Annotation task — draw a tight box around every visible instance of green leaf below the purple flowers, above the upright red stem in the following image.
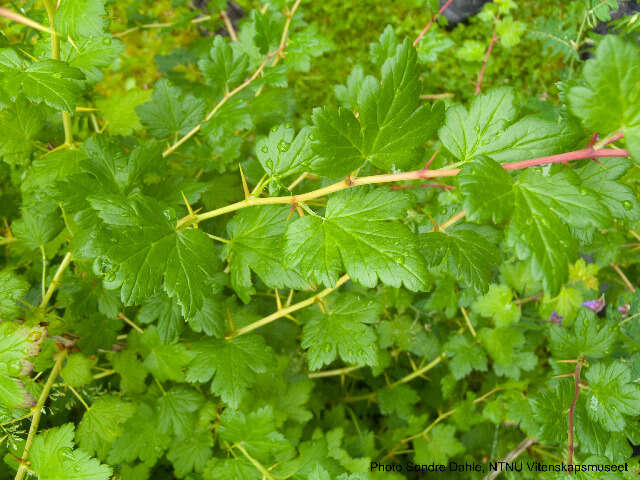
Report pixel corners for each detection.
[549,308,617,359]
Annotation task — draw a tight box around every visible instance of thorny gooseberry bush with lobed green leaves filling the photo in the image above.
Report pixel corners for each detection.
[0,0,640,480]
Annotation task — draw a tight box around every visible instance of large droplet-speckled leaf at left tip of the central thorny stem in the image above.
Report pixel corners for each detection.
[89,196,220,317]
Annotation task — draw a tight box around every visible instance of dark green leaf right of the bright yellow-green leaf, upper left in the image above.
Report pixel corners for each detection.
[135,79,205,138]
